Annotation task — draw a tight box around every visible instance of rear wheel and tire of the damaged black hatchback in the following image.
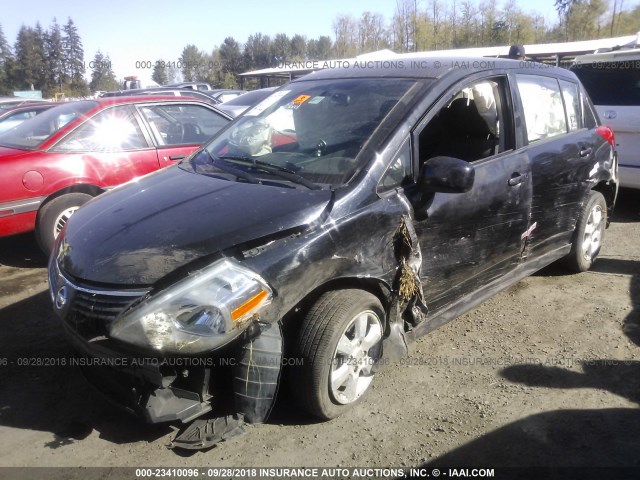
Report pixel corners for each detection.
[565,191,607,273]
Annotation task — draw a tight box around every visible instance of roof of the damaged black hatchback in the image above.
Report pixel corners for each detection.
[294,55,575,83]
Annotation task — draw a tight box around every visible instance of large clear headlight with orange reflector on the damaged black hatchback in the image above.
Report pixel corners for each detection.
[109,259,273,354]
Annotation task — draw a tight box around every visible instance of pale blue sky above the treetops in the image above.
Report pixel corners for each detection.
[0,0,564,78]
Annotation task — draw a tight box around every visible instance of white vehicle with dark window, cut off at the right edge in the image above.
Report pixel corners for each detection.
[571,49,640,188]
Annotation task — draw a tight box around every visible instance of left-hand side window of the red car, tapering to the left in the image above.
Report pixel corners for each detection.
[53,105,148,152]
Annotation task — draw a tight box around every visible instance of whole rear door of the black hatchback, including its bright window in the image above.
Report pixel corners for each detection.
[515,73,609,258]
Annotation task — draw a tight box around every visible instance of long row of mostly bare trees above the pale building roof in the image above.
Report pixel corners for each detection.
[161,0,640,88]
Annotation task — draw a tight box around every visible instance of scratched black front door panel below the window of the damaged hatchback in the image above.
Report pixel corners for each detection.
[416,152,531,311]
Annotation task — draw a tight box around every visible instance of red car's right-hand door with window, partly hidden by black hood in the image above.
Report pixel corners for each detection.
[138,102,229,167]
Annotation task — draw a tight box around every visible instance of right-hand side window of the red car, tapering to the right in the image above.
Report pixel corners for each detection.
[140,104,228,145]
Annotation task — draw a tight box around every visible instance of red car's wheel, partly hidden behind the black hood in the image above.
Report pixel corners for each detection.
[36,193,93,255]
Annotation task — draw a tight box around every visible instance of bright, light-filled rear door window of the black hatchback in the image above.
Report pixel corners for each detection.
[516,75,567,142]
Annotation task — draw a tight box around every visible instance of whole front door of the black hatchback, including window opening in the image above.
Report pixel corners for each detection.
[414,75,531,312]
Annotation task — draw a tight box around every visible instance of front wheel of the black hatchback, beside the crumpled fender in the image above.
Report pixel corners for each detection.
[292,290,384,420]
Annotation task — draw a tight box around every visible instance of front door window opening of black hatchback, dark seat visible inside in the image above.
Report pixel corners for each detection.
[418,78,511,166]
